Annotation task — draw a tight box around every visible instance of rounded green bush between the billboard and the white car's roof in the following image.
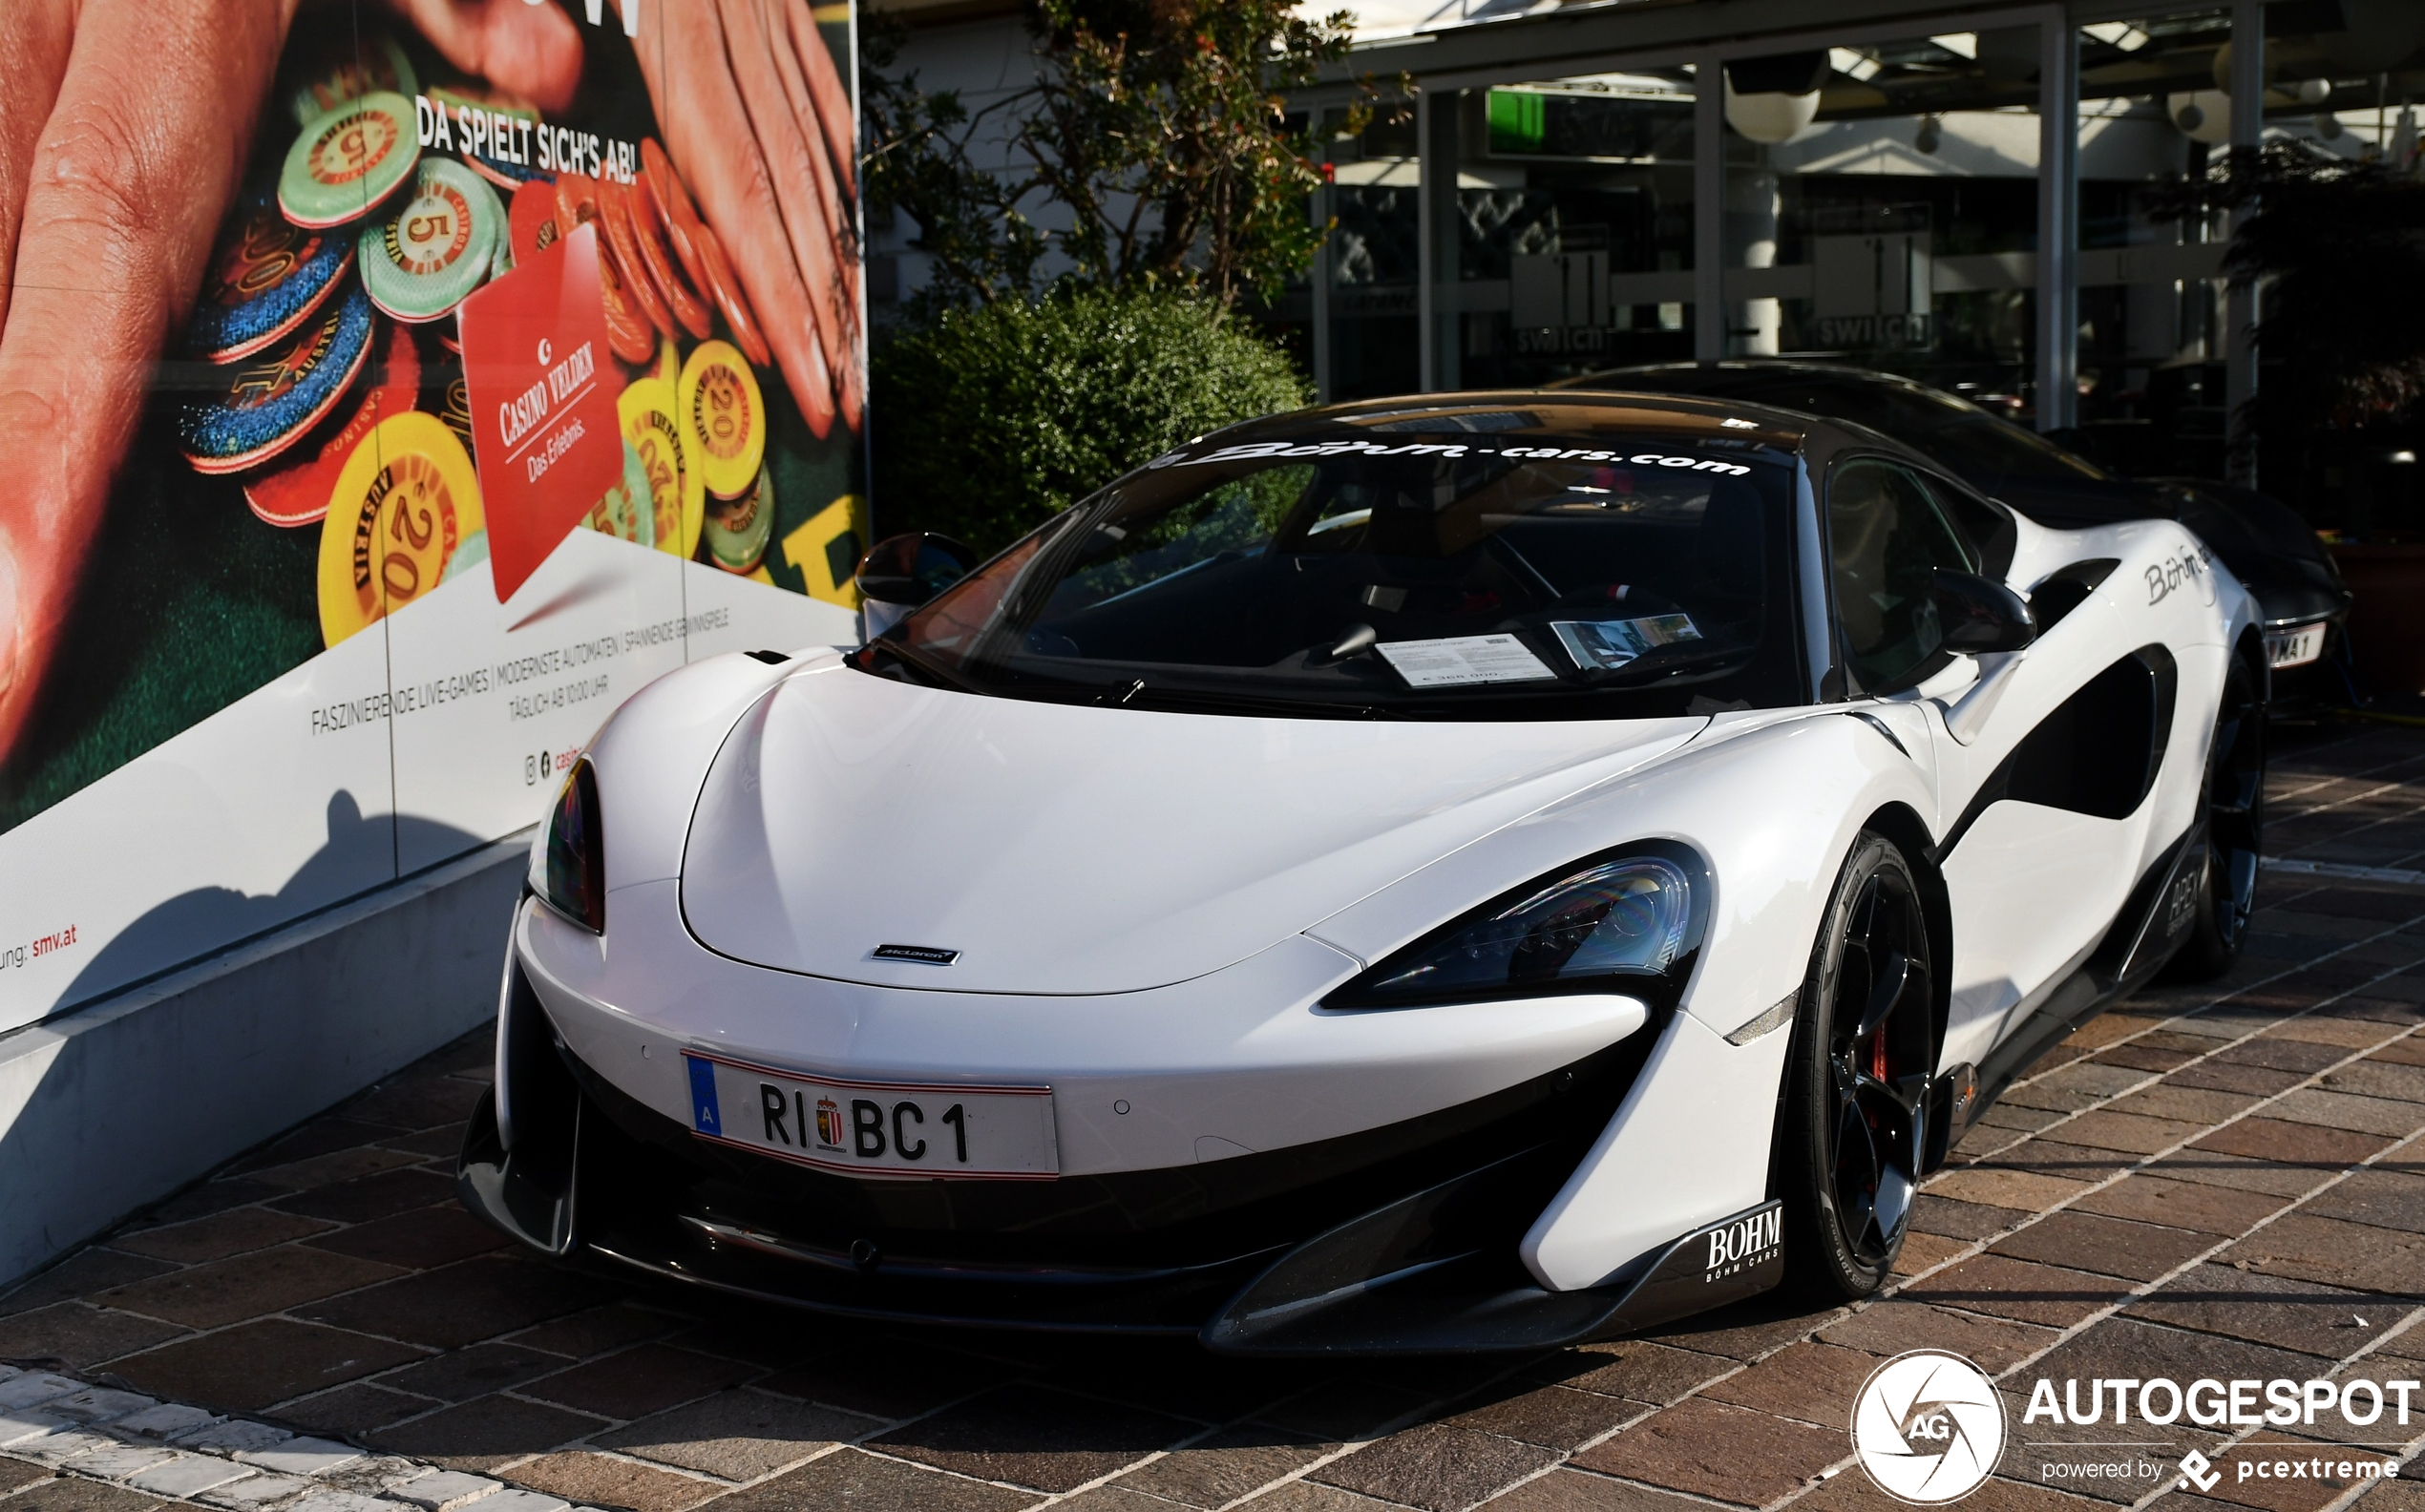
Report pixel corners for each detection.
[868,293,1312,555]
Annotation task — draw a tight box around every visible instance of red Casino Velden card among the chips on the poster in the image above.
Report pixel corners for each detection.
[458,225,623,603]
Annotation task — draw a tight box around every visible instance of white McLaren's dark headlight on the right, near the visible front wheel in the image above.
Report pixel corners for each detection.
[1324,841,1710,1008]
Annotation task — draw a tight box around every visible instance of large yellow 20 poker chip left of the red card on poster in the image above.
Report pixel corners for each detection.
[320,410,488,644]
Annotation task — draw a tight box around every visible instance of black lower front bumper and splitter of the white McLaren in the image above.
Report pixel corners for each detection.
[458,892,1780,1354]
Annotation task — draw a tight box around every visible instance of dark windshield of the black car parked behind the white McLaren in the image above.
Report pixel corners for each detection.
[1600,368,2107,492]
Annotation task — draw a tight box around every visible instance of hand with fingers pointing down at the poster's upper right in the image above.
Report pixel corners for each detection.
[633,0,866,433]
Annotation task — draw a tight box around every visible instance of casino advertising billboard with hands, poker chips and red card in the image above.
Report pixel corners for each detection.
[0,0,866,1030]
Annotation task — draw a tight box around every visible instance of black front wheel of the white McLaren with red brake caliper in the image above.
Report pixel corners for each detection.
[1778,833,1935,1299]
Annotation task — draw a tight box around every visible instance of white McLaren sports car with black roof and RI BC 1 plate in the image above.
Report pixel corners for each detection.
[458,392,2267,1354]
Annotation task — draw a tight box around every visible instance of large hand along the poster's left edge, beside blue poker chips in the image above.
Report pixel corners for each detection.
[0,0,582,761]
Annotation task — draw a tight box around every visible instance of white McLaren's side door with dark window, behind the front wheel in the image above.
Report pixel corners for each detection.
[1828,455,2129,1066]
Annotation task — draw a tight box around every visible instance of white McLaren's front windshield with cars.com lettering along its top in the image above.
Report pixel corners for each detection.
[856,422,1802,720]
